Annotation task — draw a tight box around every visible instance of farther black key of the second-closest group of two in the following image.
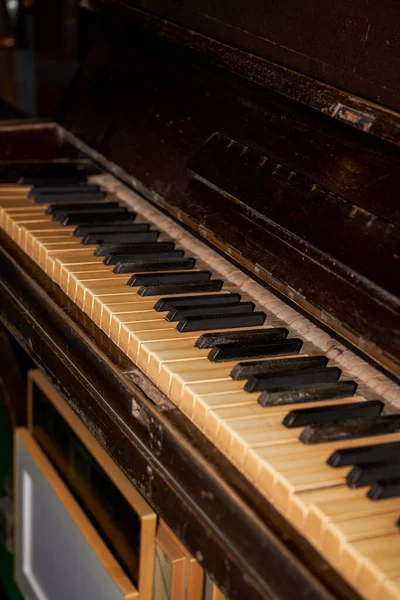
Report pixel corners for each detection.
[195,327,289,350]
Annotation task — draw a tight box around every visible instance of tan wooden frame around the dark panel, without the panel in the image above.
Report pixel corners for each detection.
[28,369,157,600]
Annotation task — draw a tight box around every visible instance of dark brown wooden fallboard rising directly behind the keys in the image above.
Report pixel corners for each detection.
[57,18,400,376]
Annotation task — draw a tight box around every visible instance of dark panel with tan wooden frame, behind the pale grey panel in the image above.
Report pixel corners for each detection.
[28,370,156,600]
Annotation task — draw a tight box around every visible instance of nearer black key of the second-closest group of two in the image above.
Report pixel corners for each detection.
[208,338,303,362]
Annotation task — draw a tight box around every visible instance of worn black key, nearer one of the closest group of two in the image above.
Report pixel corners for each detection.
[299,415,400,444]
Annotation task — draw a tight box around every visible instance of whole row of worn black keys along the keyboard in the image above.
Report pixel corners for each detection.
[32,177,400,506]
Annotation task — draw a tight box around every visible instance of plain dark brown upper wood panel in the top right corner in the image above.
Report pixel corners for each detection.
[117,0,400,110]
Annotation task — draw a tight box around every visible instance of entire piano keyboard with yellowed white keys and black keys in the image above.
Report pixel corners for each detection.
[0,171,400,600]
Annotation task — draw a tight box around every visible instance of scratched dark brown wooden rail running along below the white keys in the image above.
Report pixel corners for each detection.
[0,230,357,600]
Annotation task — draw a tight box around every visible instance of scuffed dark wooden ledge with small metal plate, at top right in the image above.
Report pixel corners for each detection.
[90,0,400,146]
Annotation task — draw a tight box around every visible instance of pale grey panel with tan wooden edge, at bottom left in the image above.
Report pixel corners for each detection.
[15,428,139,600]
